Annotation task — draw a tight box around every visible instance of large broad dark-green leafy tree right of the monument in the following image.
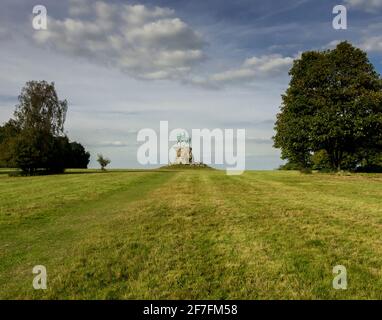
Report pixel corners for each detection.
[274,42,382,170]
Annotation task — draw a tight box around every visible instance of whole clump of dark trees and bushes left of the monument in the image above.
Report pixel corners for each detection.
[0,81,90,175]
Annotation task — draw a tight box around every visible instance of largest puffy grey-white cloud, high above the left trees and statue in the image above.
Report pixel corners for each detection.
[34,0,205,79]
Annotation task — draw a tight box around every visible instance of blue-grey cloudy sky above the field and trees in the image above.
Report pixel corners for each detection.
[0,0,382,170]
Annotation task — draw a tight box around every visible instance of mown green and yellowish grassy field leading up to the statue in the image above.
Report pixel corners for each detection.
[0,170,382,299]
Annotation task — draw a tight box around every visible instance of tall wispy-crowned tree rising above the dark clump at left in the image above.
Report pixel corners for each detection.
[13,81,67,174]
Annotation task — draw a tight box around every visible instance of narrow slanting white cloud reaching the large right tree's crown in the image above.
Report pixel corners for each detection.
[193,54,296,87]
